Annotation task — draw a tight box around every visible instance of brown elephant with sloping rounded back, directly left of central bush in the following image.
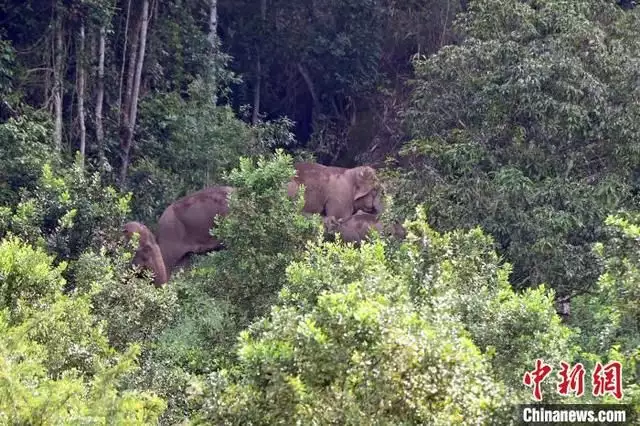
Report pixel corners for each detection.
[156,186,233,276]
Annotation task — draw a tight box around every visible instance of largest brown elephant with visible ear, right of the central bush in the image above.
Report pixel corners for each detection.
[287,163,382,219]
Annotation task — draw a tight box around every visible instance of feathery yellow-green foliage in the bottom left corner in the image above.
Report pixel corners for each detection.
[0,314,165,425]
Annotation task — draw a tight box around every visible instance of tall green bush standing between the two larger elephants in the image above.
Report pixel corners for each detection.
[214,151,323,317]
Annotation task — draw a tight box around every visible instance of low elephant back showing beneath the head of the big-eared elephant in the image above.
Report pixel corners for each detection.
[323,211,406,243]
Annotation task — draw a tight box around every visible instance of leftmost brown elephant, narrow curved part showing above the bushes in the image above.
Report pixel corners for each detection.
[122,222,168,287]
